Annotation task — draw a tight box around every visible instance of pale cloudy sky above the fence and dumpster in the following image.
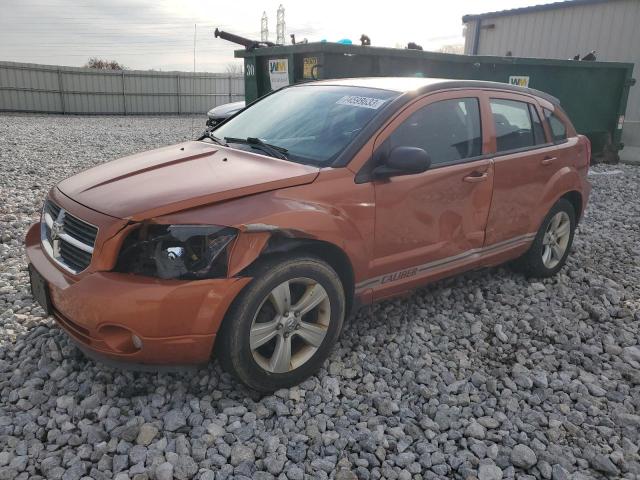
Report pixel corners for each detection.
[0,0,551,72]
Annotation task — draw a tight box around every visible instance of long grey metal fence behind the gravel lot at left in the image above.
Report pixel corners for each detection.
[0,62,244,115]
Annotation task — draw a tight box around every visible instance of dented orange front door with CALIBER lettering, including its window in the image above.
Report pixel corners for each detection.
[370,91,493,299]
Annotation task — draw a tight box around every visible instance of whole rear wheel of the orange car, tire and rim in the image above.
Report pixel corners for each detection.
[514,198,576,277]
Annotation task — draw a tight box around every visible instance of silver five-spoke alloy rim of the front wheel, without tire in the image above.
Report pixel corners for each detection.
[249,278,331,373]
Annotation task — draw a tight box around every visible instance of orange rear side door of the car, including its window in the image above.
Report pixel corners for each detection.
[482,92,568,246]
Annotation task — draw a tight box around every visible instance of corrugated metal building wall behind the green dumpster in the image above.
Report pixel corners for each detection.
[465,0,640,146]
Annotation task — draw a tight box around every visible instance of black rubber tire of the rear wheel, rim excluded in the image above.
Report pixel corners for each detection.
[513,198,576,278]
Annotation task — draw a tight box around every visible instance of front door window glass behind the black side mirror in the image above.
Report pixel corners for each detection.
[387,98,482,165]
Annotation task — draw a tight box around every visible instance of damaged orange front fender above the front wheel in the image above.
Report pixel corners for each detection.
[157,169,375,281]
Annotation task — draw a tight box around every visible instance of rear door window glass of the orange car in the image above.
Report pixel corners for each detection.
[490,98,536,152]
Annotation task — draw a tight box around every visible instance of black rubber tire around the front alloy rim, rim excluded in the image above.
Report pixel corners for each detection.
[216,255,345,392]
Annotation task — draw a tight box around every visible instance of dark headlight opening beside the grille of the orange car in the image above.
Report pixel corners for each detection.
[116,225,237,280]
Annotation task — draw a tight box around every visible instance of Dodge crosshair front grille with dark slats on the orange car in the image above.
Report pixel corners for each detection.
[40,200,98,273]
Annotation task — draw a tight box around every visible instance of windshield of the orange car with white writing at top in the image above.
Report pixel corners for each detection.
[214,85,398,166]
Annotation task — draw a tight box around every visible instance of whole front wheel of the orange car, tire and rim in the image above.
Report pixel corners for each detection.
[216,256,345,391]
